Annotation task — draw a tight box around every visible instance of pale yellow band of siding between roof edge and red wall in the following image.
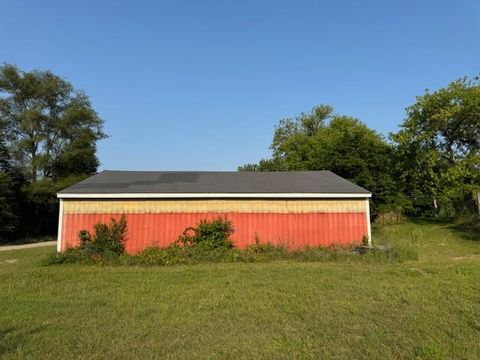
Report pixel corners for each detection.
[63,199,366,214]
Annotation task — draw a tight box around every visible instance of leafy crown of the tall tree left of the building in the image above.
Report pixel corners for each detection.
[0,64,105,182]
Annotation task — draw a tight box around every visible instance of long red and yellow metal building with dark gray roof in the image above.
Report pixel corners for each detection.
[57,171,371,253]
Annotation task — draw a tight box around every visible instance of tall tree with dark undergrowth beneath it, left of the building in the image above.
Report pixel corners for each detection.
[0,64,105,241]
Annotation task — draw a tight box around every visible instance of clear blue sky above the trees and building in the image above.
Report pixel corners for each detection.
[0,0,480,170]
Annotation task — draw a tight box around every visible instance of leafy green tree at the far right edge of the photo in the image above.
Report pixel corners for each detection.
[392,78,480,217]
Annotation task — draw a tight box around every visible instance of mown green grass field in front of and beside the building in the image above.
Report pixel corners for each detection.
[0,221,480,359]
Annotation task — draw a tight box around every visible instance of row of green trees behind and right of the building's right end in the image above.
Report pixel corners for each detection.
[238,77,480,218]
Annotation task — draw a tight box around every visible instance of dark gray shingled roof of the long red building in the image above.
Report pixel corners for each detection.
[59,170,370,195]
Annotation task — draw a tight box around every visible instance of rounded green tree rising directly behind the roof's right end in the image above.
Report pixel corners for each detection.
[239,105,405,215]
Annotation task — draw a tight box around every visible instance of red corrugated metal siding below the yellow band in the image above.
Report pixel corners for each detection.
[62,212,367,253]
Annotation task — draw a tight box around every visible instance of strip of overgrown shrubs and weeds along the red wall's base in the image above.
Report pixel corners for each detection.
[46,217,418,266]
